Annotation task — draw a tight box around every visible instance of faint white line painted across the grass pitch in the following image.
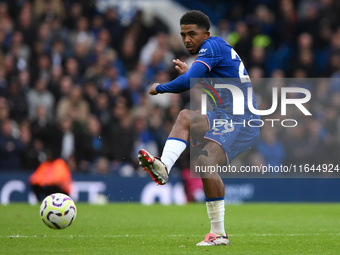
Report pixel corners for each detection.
[0,233,340,238]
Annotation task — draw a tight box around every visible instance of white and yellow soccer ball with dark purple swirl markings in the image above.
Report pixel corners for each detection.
[40,193,77,229]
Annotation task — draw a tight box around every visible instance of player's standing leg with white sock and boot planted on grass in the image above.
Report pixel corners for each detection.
[197,142,229,246]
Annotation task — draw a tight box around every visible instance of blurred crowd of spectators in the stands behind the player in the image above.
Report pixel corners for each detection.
[0,0,340,175]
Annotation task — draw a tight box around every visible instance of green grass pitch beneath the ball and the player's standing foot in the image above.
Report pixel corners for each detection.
[0,203,340,255]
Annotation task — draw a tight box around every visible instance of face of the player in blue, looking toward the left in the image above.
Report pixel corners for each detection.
[181,25,210,55]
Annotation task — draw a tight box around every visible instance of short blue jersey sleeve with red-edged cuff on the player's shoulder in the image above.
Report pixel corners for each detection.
[194,40,222,72]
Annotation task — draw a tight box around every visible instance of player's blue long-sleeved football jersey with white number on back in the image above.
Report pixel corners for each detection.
[156,36,258,119]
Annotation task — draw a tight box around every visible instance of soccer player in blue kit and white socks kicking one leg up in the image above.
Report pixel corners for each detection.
[138,10,260,246]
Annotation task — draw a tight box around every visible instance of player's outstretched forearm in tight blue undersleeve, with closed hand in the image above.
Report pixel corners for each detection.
[149,62,209,95]
